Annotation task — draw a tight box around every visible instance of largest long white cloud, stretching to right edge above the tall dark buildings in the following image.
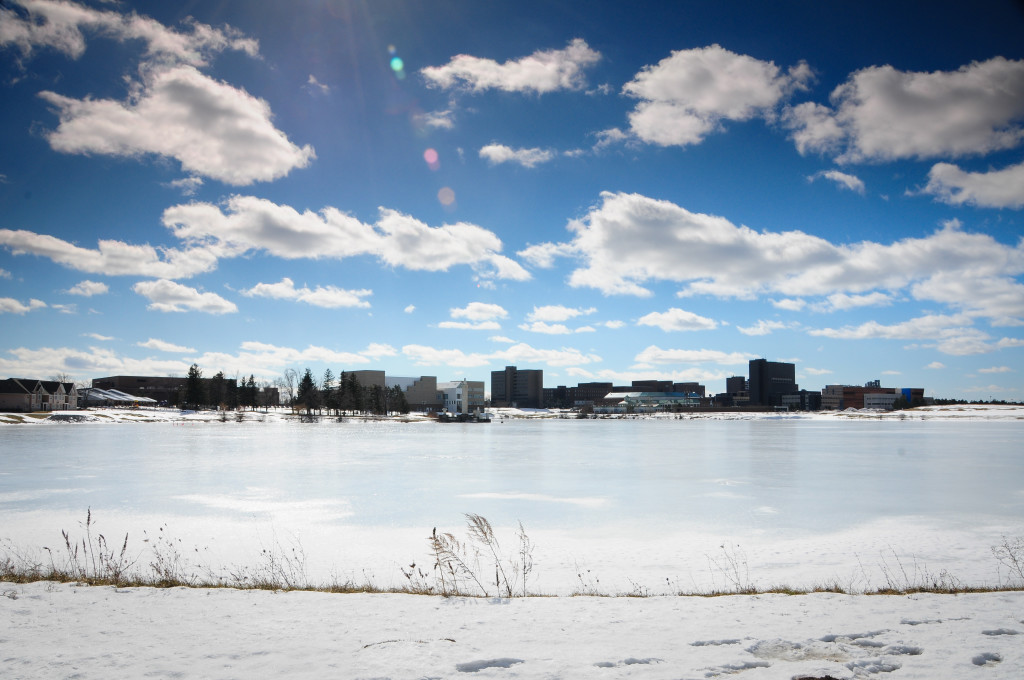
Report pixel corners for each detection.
[520,193,1024,325]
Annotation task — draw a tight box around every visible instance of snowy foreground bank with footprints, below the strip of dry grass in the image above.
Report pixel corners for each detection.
[0,583,1024,680]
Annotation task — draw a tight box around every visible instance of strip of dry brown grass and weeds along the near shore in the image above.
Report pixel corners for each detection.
[0,509,1024,598]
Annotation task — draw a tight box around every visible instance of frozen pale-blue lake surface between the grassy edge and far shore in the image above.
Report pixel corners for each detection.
[0,411,1024,591]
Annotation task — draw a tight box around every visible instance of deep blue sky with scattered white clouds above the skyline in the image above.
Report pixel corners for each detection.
[0,0,1024,399]
